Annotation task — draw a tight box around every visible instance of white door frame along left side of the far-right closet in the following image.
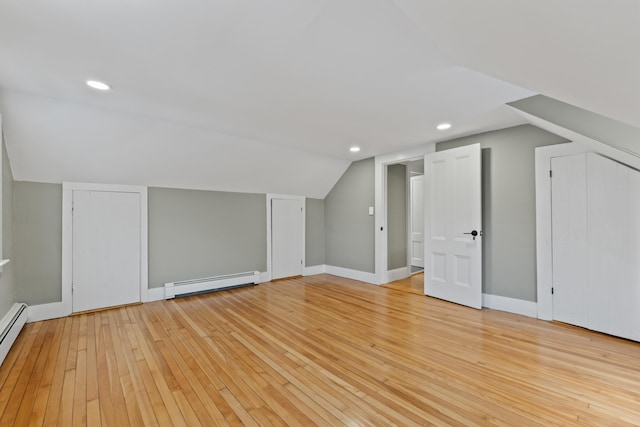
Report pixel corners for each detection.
[536,142,592,320]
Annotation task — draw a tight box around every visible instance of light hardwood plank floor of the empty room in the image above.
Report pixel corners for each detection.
[0,275,640,427]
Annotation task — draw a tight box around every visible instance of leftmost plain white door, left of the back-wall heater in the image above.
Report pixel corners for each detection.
[72,190,141,312]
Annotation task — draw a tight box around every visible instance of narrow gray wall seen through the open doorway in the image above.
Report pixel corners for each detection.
[387,162,408,270]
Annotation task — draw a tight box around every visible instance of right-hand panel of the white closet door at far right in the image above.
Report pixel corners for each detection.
[586,153,640,340]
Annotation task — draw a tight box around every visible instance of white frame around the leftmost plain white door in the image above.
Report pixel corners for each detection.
[61,182,149,317]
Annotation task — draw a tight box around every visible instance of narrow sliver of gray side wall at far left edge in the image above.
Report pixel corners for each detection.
[0,141,17,319]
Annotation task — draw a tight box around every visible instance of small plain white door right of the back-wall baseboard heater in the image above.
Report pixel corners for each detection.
[271,199,303,279]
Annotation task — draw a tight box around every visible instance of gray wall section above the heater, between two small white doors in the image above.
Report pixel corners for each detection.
[149,188,267,288]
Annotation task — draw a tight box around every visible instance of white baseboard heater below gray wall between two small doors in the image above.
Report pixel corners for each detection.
[164,271,260,299]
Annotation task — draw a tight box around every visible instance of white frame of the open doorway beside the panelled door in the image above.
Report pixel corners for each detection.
[374,143,436,285]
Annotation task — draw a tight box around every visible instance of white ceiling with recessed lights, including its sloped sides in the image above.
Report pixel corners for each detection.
[0,0,640,197]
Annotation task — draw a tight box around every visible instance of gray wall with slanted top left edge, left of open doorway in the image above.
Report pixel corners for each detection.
[324,158,375,273]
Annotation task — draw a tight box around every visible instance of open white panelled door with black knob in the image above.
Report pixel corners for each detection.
[424,144,482,308]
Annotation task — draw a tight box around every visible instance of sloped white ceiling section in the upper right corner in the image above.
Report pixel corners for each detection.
[394,0,640,127]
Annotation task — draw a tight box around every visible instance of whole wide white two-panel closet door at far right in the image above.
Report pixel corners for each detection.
[551,153,640,341]
